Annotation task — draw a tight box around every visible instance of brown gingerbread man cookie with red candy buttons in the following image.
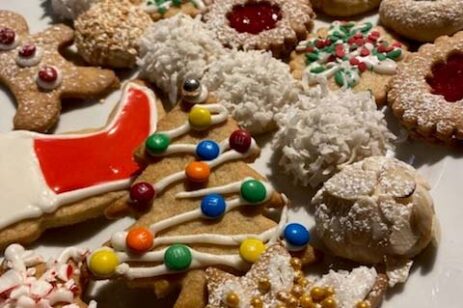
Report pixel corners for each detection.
[0,11,118,132]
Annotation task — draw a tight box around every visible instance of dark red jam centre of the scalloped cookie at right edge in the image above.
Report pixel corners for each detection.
[426,53,463,103]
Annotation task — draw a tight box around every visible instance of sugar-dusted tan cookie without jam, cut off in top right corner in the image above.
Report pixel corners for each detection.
[379,0,463,42]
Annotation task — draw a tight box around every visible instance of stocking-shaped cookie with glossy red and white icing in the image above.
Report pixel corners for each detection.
[0,83,162,248]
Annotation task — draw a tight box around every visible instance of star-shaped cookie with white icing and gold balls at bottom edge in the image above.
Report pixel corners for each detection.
[206,243,387,308]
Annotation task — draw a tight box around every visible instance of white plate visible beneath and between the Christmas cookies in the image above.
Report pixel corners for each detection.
[0,0,463,308]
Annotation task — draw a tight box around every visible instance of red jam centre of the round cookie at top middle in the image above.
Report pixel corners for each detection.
[227,1,281,34]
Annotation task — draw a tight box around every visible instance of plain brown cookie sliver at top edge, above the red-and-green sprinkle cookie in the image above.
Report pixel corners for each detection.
[310,0,381,17]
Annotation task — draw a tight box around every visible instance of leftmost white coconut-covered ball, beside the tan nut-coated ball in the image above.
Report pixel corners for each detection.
[138,14,225,103]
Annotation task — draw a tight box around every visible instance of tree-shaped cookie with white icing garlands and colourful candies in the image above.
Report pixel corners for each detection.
[88,80,315,307]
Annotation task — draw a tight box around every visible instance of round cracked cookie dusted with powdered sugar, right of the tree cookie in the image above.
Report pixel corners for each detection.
[312,156,437,284]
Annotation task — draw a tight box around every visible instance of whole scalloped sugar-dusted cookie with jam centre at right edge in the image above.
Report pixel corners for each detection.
[388,32,463,143]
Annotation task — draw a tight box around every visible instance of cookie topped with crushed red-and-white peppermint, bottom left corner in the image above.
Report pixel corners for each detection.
[0,244,96,308]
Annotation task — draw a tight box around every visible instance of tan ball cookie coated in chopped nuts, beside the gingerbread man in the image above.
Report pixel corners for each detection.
[75,0,152,68]
